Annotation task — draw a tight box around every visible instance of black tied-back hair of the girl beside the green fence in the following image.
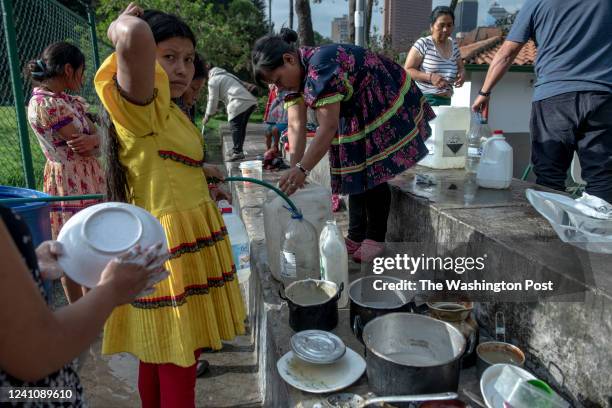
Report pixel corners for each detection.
[26,42,85,84]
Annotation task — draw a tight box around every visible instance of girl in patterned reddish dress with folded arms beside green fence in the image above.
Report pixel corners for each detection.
[26,42,106,303]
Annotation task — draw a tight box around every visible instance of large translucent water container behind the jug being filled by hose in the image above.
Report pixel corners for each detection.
[264,183,333,280]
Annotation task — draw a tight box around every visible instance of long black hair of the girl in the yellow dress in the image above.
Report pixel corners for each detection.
[103,10,196,202]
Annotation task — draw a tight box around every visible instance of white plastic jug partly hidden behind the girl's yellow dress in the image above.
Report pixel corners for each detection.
[218,200,251,283]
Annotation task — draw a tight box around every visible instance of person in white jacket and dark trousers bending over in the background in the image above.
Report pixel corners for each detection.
[202,67,257,161]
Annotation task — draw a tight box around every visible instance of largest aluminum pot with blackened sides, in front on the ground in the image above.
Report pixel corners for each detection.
[363,313,466,404]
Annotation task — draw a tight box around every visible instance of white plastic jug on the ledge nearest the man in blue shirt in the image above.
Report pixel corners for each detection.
[476,130,513,189]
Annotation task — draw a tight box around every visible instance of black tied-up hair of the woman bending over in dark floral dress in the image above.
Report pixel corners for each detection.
[251,28,298,87]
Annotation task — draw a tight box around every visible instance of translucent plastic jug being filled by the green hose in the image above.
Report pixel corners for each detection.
[278,216,321,286]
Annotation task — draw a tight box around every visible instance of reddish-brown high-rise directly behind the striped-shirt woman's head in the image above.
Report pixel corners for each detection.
[383,0,431,52]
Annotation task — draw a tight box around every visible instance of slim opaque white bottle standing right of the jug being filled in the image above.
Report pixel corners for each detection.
[319,221,349,308]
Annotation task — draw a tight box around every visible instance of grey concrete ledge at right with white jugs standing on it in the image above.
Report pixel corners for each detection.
[387,168,612,407]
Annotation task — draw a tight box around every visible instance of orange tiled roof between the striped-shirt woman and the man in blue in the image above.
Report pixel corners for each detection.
[459,36,537,66]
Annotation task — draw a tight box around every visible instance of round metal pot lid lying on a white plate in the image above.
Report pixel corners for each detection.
[291,330,346,364]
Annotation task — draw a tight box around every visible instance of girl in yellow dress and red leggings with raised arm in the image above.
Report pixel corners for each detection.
[95,3,245,408]
